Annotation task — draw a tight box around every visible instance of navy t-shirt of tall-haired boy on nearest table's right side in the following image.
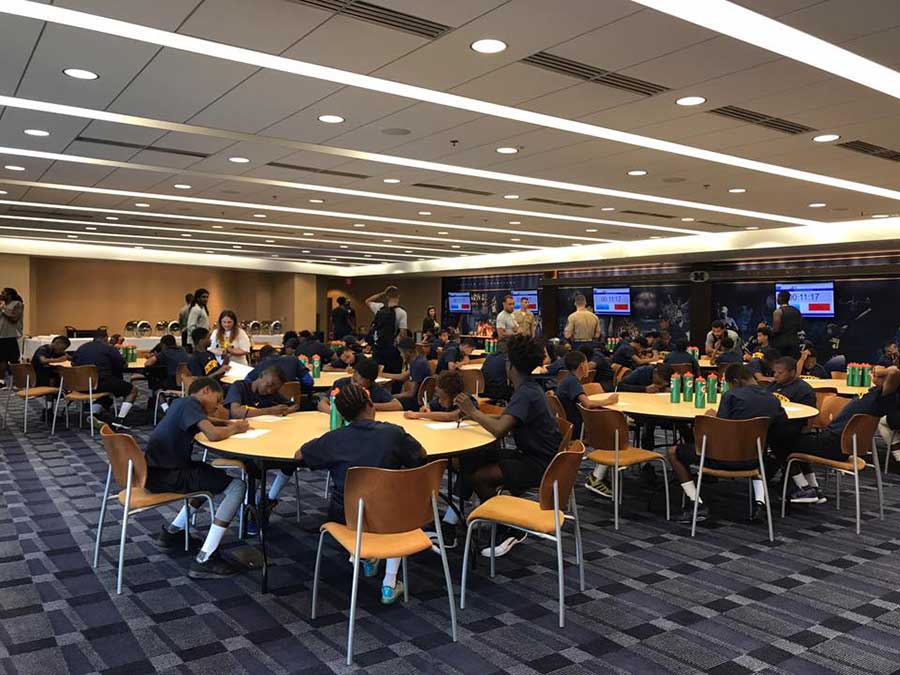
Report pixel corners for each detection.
[503,381,562,466]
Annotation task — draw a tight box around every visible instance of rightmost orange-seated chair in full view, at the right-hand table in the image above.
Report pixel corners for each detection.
[781,412,884,534]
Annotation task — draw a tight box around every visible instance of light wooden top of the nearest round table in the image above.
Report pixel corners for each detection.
[195,411,494,460]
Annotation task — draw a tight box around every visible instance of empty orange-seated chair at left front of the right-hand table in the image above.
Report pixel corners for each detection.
[578,405,671,530]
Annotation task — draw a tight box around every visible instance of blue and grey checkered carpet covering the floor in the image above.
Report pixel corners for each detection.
[0,394,900,675]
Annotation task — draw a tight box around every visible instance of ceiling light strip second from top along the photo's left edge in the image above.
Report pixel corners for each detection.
[0,96,844,227]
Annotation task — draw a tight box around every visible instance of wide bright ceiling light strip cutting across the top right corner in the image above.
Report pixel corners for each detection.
[633,0,900,98]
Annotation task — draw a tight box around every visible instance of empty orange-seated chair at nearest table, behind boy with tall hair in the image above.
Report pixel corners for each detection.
[459,441,584,628]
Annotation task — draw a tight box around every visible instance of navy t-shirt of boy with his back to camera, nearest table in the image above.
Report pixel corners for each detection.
[300,420,424,526]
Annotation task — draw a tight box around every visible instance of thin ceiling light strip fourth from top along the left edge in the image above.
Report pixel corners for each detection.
[0,178,620,248]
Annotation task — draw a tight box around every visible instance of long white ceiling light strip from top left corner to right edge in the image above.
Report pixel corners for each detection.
[0,0,900,199]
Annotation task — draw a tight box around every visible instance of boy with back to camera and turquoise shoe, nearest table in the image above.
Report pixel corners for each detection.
[295,382,425,605]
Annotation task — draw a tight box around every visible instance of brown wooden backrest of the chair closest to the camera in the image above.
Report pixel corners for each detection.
[344,459,447,534]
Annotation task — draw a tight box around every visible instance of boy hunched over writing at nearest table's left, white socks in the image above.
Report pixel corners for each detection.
[145,377,250,579]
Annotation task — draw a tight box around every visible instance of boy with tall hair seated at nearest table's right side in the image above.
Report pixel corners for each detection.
[454,335,562,557]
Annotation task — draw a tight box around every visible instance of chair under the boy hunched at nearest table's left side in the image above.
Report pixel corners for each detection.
[93,424,213,595]
